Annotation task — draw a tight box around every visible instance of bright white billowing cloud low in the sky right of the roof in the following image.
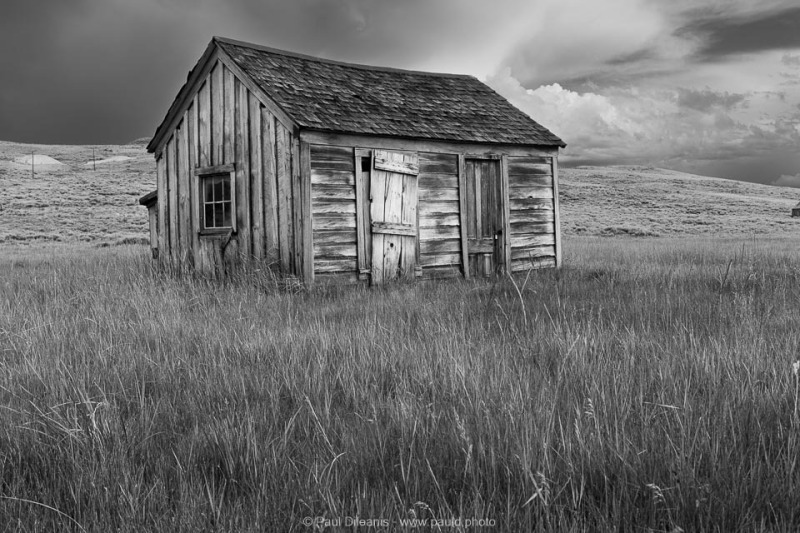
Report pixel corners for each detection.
[487,69,800,166]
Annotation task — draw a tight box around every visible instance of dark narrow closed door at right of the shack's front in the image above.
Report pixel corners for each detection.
[465,159,506,277]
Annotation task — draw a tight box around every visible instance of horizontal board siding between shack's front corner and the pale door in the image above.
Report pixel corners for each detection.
[306,144,358,279]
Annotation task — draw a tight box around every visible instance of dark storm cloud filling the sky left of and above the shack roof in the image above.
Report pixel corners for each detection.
[0,0,488,143]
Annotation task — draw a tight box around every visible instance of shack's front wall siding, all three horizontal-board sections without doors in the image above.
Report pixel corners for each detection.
[310,141,560,281]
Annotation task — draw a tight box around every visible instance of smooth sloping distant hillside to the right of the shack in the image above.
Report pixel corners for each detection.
[559,166,800,236]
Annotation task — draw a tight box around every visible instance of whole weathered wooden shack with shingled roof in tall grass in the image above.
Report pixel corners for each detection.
[147,37,565,284]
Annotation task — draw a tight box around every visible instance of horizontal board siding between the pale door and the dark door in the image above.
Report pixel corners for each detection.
[417,152,462,278]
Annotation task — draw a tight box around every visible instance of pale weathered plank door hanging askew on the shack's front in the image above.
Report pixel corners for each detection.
[369,150,419,285]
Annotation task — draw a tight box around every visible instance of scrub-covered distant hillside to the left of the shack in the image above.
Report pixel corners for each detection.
[0,140,156,244]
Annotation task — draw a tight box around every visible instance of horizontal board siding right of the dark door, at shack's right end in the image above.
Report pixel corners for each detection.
[508,157,556,272]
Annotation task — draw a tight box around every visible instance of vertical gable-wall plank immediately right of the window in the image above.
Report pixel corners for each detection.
[235,79,251,259]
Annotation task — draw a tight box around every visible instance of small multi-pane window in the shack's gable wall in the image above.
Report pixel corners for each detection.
[195,165,236,233]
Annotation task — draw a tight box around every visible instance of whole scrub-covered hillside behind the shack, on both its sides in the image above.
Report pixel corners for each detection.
[0,139,800,245]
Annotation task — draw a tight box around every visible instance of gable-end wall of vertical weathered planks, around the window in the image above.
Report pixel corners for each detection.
[157,61,304,275]
